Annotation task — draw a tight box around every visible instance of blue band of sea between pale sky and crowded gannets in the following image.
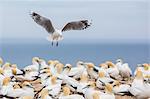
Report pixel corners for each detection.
[0,43,150,71]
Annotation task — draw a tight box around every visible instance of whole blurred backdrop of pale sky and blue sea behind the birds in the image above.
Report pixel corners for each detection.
[0,0,150,69]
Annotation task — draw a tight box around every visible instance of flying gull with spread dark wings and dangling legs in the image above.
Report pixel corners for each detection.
[31,12,91,46]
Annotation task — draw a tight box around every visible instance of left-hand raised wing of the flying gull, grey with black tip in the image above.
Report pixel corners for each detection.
[31,12,55,33]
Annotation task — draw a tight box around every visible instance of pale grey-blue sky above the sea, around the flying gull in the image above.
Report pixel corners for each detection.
[0,0,150,42]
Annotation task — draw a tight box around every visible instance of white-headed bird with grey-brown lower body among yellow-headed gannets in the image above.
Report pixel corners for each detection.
[116,59,132,79]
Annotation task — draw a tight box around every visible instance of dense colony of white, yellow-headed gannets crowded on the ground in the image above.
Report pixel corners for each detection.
[0,57,150,99]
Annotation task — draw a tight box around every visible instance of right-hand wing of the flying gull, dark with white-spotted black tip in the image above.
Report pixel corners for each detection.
[62,20,91,32]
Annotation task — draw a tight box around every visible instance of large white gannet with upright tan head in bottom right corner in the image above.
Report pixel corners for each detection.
[129,70,150,99]
